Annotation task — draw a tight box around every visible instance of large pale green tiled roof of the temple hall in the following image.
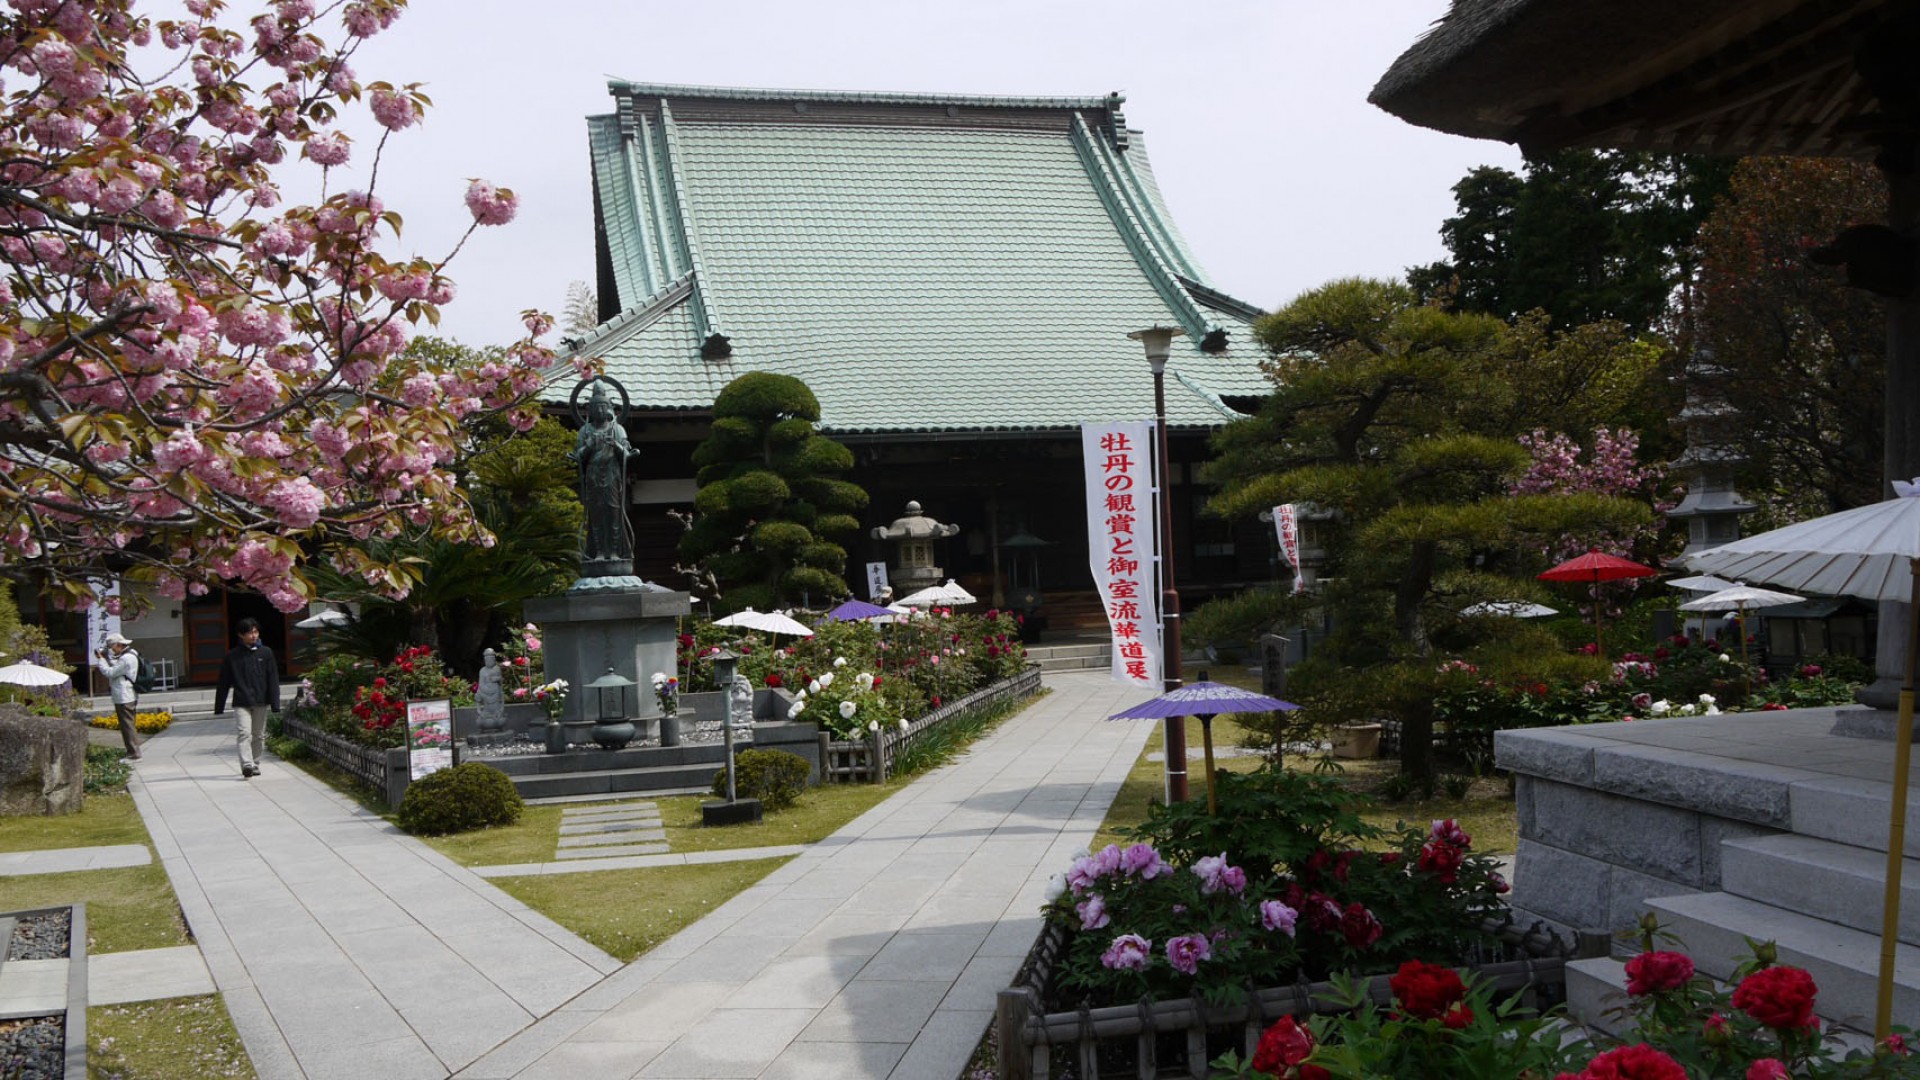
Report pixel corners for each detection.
[555,83,1269,432]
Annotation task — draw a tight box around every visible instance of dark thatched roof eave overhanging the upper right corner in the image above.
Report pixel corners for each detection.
[1369,0,1920,158]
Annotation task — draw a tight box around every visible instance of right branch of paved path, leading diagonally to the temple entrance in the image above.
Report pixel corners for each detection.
[459,673,1152,1080]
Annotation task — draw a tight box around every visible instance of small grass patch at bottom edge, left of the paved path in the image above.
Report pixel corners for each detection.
[86,994,255,1080]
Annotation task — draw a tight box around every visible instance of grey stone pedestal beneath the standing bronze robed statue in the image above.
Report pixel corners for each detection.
[526,578,691,724]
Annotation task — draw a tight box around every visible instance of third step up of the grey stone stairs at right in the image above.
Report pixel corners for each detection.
[1720,832,1920,945]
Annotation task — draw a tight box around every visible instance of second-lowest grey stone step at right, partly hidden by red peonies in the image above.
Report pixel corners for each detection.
[1647,892,1920,1030]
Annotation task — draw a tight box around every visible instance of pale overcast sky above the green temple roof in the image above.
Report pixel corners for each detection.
[334,0,1519,346]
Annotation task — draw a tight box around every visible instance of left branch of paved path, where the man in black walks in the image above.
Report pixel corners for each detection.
[131,721,620,1080]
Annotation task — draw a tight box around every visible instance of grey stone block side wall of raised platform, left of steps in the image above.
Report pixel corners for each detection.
[1494,721,1791,932]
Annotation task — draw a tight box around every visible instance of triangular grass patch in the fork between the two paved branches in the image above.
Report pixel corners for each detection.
[493,859,785,961]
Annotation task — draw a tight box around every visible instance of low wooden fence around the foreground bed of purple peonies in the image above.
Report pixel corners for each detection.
[993,915,1609,1080]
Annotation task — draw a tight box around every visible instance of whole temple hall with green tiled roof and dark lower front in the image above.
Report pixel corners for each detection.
[553,81,1273,622]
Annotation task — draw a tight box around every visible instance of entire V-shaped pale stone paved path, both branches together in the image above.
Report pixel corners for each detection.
[132,673,1152,1080]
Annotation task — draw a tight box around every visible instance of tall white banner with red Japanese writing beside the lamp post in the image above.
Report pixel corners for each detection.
[1081,421,1162,690]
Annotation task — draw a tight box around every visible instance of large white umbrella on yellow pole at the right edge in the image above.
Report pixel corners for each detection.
[1686,480,1920,1038]
